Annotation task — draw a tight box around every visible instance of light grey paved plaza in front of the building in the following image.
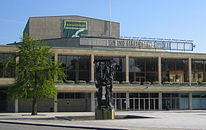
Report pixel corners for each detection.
[0,110,206,130]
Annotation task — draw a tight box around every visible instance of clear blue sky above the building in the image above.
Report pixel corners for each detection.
[0,0,206,53]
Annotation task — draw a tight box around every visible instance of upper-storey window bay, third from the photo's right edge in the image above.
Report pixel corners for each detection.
[129,58,158,82]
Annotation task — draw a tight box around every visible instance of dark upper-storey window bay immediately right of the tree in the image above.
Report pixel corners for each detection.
[58,55,91,82]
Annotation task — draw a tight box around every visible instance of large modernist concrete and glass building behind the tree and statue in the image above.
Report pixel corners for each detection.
[0,16,206,112]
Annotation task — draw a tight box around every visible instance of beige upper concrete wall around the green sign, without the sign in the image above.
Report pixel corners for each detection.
[24,16,120,40]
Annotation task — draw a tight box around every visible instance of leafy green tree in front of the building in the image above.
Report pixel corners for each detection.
[7,35,65,115]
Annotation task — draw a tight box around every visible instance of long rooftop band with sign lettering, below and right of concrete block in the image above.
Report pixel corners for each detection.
[80,38,193,51]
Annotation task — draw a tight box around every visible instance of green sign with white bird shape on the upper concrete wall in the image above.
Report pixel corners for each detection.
[63,20,88,37]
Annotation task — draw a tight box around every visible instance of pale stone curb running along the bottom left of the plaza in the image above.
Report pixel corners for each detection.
[0,120,126,130]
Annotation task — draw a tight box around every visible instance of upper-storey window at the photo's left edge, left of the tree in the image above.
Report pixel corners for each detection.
[0,53,15,78]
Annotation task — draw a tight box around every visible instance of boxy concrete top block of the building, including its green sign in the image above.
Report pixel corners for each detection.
[24,16,120,40]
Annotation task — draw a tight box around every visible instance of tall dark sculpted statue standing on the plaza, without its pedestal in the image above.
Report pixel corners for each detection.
[94,60,116,110]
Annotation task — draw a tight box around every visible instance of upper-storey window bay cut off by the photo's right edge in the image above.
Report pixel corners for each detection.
[192,60,206,83]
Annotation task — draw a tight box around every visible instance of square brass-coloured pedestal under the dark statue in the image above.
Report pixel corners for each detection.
[95,109,115,120]
